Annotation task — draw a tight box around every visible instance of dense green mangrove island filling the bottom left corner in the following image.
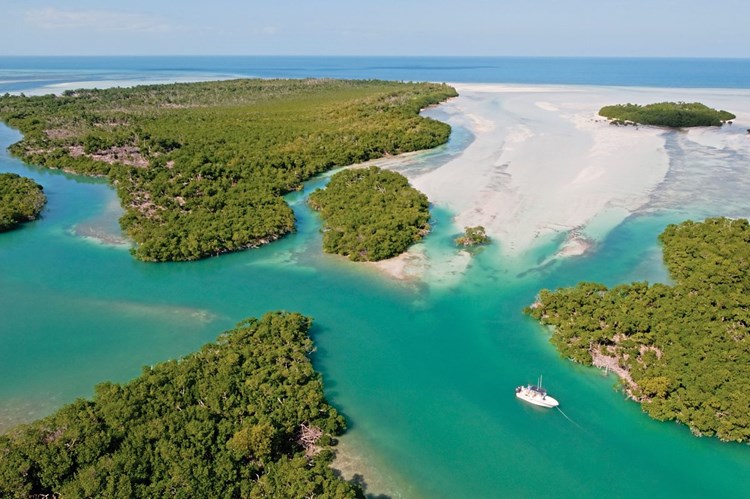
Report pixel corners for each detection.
[0,312,362,499]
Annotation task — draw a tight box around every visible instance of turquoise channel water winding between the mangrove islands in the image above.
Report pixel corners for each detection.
[0,60,750,497]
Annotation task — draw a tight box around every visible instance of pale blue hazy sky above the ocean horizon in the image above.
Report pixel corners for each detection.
[0,0,750,58]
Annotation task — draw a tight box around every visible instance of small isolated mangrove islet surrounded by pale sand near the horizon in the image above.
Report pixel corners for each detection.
[599,102,736,128]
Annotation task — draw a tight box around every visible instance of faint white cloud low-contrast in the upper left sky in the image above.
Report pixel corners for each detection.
[25,7,174,33]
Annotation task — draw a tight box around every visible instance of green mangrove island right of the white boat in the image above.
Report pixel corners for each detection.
[528,218,750,441]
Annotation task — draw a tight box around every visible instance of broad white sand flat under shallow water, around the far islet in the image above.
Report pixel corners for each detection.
[378,84,750,278]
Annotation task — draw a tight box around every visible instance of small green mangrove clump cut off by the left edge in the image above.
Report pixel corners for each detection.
[0,173,47,232]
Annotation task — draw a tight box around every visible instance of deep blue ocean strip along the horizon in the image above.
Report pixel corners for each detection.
[0,56,750,92]
